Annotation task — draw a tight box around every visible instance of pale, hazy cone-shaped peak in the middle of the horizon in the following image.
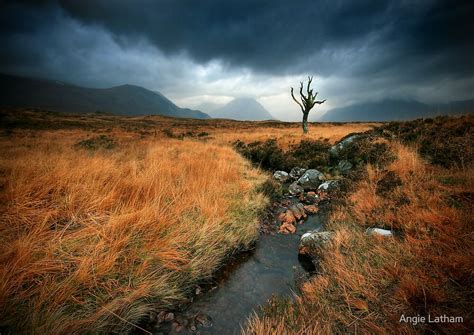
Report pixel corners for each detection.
[209,98,274,121]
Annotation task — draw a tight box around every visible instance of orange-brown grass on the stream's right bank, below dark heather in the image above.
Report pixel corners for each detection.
[246,144,474,334]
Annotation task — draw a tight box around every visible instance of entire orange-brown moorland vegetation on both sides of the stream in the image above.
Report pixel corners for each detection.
[0,110,474,334]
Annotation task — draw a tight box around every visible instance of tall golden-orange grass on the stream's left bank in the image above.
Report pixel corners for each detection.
[0,132,266,334]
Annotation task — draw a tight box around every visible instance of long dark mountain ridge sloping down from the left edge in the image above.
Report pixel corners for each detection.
[0,74,209,119]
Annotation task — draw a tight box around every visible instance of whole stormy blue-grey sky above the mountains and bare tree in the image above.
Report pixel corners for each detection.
[0,0,474,121]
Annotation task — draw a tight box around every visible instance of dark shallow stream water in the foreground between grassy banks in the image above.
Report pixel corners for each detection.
[161,215,322,334]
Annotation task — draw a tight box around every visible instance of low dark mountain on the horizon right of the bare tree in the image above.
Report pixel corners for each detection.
[317,99,474,122]
